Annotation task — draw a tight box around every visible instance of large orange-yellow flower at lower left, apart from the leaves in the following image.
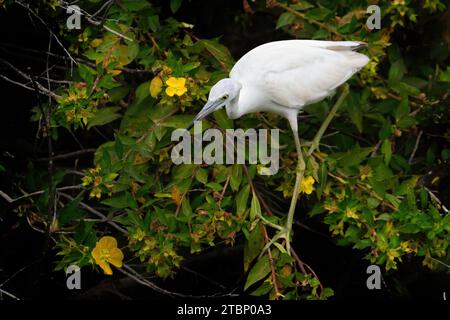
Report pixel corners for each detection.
[92,236,123,275]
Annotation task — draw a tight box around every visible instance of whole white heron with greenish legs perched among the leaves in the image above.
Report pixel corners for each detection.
[188,40,369,254]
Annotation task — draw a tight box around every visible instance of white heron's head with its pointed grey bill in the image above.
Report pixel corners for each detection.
[186,78,242,130]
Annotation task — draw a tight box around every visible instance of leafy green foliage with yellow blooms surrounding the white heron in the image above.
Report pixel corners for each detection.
[7,0,450,299]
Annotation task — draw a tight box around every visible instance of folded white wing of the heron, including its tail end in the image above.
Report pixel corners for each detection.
[230,40,369,109]
